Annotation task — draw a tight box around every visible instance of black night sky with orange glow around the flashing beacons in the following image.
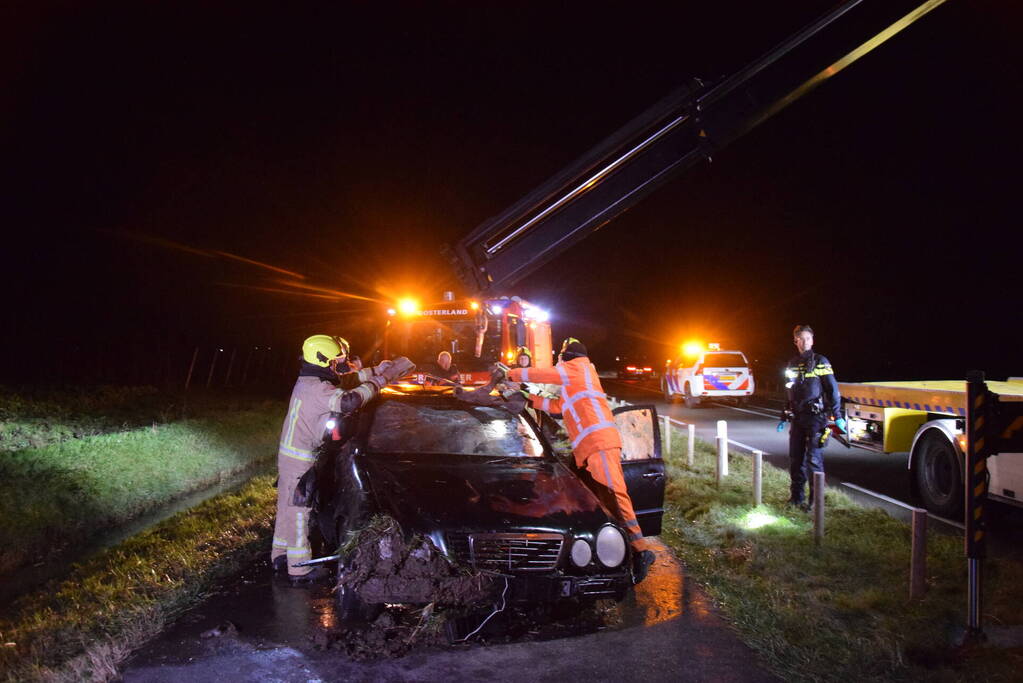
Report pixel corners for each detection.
[0,0,1023,380]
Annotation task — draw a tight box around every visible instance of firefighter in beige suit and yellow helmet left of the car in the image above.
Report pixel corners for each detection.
[270,334,414,584]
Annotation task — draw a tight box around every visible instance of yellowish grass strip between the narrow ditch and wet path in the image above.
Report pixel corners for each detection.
[0,475,276,681]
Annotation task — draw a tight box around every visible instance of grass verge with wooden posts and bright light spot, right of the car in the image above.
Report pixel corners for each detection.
[662,432,1023,681]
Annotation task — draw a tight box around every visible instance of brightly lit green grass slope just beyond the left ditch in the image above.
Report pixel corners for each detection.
[0,402,283,575]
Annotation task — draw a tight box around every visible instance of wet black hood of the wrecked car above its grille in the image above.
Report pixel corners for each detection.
[362,454,609,534]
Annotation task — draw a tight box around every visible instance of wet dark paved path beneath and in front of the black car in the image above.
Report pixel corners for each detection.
[122,546,773,683]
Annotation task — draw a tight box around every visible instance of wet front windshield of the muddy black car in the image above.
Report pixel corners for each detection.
[368,401,543,458]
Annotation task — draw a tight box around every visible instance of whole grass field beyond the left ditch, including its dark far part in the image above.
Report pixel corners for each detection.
[0,389,284,575]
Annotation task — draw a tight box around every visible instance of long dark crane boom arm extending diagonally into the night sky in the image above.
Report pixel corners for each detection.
[448,0,945,292]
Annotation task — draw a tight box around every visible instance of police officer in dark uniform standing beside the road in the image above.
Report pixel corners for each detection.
[780,325,845,510]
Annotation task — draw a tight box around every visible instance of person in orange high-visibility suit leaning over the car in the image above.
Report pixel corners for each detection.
[508,337,654,583]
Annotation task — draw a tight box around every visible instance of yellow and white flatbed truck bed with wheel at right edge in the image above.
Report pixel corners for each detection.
[839,378,1023,518]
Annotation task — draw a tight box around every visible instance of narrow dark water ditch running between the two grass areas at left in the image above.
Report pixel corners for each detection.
[0,465,269,607]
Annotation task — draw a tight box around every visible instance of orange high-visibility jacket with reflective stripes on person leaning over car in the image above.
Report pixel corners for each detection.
[508,356,622,465]
